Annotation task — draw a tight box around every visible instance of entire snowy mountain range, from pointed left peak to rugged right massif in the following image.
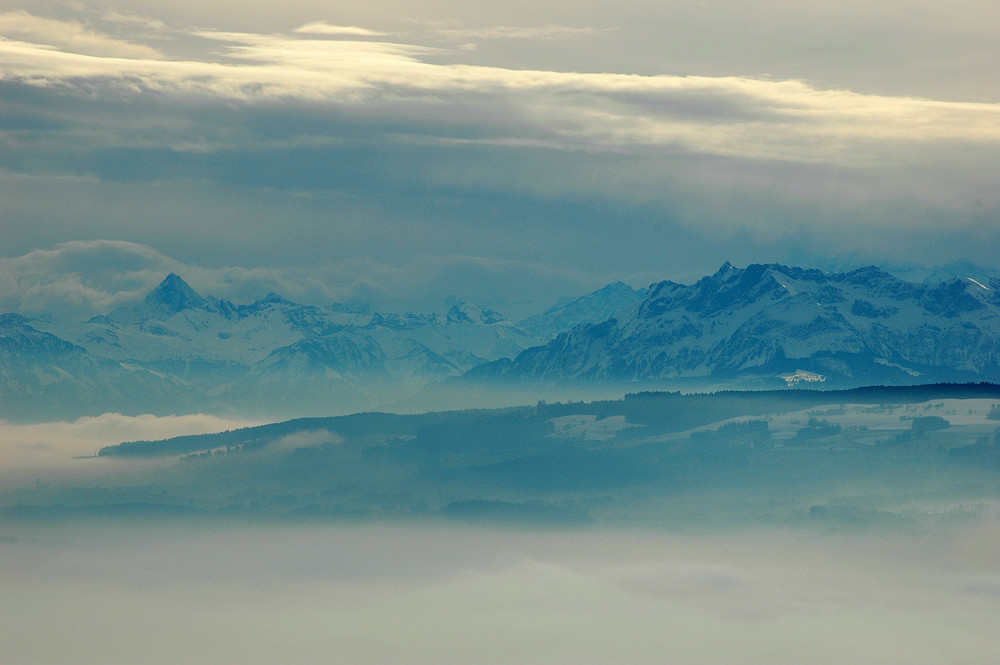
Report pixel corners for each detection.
[0,263,1000,420]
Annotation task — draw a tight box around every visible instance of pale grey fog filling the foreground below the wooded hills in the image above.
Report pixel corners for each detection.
[0,522,1000,665]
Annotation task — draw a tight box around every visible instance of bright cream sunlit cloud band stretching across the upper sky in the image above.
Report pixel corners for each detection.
[0,13,1000,164]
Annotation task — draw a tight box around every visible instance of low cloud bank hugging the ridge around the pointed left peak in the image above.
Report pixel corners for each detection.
[0,240,616,323]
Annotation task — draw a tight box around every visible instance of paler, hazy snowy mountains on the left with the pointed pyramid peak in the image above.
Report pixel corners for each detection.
[0,273,643,419]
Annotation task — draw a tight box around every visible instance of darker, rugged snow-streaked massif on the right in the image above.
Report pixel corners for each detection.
[469,263,1000,383]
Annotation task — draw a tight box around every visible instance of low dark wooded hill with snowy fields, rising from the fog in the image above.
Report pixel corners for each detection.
[7,384,1000,528]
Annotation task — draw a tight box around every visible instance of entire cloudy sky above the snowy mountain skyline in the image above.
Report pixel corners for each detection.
[0,0,1000,316]
